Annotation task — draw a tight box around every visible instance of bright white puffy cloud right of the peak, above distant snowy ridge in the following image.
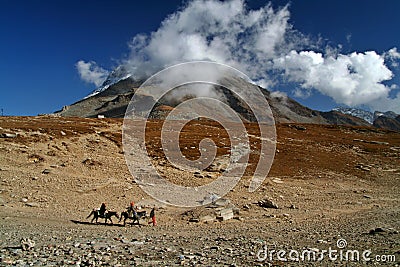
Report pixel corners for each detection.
[273,51,393,109]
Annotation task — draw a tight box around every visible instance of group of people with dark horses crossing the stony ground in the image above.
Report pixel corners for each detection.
[86,202,156,226]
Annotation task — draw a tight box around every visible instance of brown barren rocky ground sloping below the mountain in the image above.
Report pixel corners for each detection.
[0,116,400,266]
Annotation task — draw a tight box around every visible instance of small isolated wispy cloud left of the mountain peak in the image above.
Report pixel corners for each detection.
[75,60,109,87]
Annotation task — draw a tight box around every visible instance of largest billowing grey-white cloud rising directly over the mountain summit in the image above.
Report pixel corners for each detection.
[125,0,296,84]
